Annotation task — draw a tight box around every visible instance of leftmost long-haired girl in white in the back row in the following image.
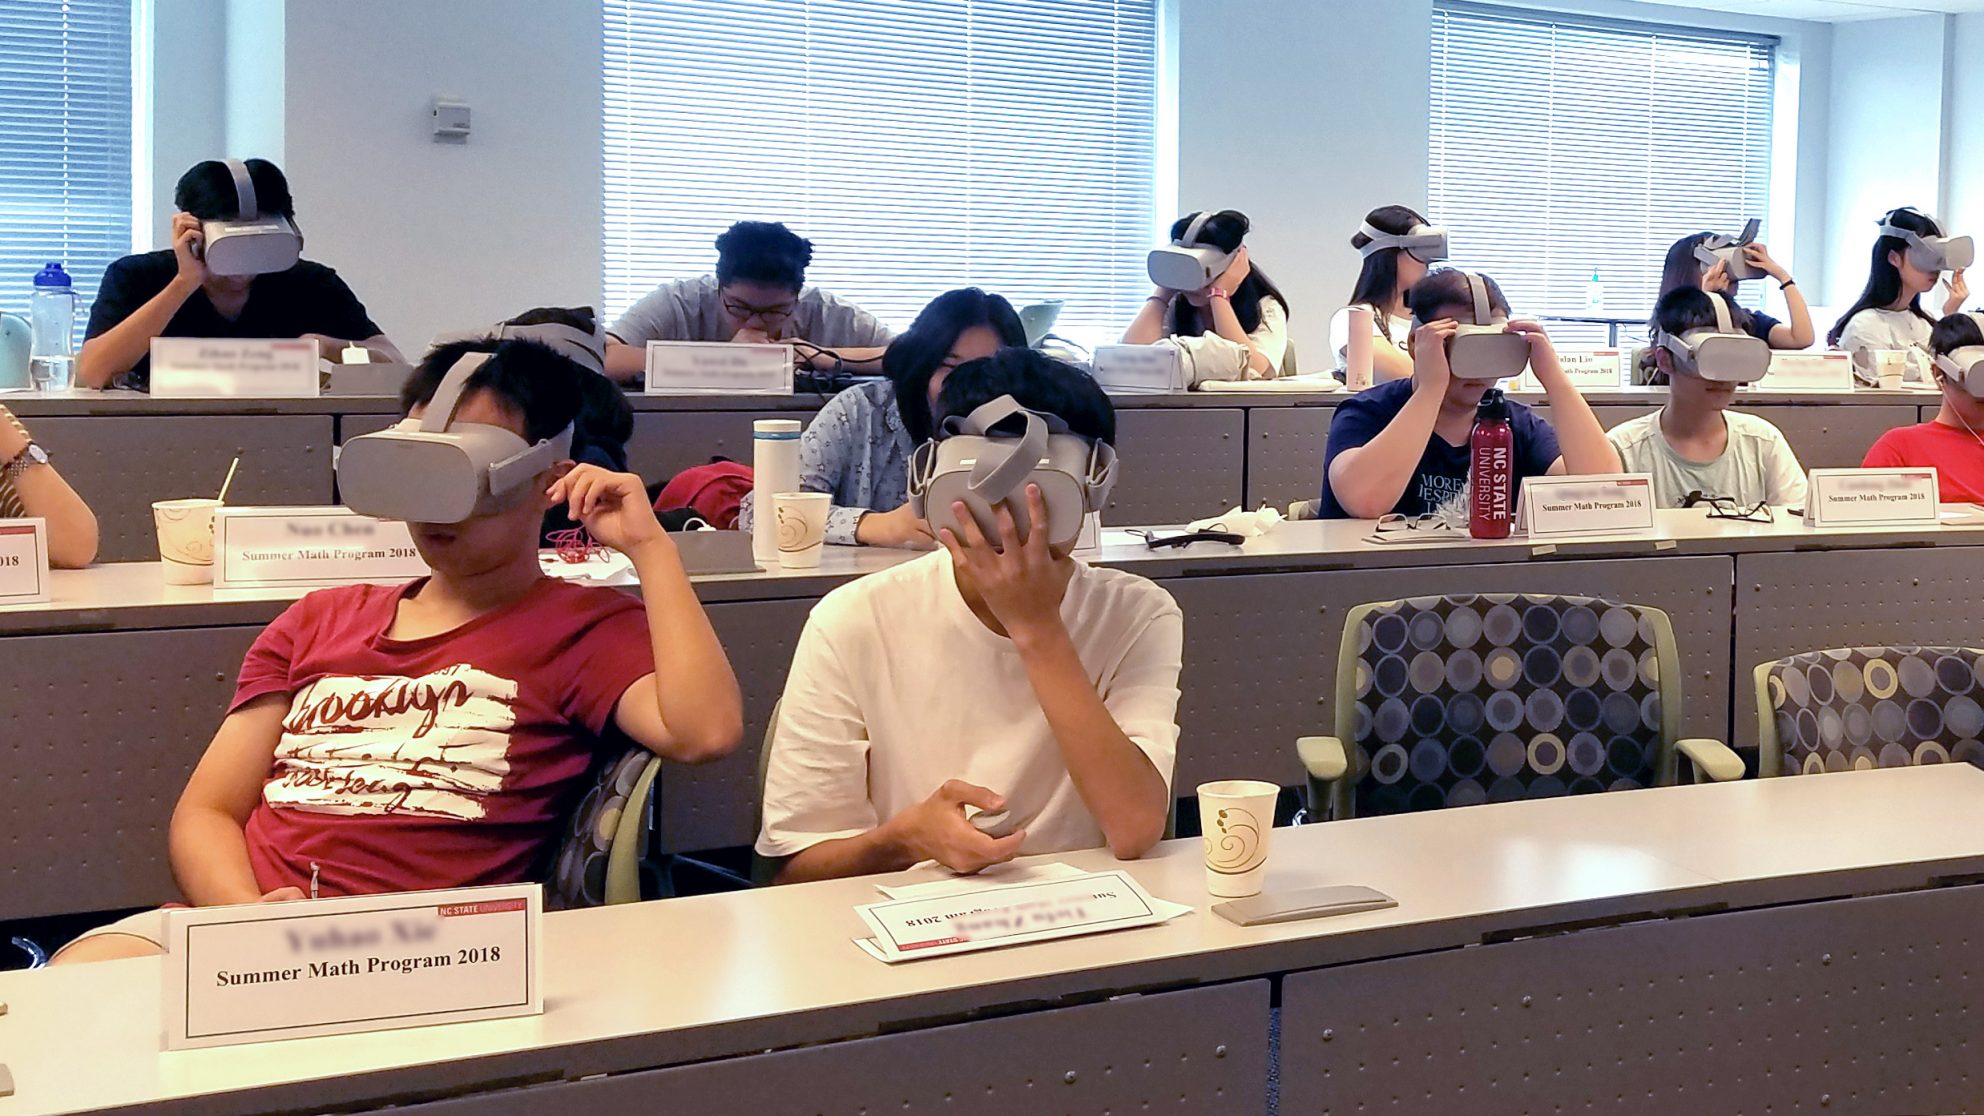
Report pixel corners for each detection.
[1123,209,1294,379]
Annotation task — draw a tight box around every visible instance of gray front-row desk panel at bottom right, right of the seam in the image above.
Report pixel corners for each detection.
[1282,886,1984,1116]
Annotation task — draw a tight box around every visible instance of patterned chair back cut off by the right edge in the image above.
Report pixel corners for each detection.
[1756,647,1984,774]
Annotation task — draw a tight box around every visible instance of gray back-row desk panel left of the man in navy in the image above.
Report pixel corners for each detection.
[1103,407,1246,524]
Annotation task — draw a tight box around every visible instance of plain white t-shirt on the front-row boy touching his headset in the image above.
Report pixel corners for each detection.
[758,550,1184,856]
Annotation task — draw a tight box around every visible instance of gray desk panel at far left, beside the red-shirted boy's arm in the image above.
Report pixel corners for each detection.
[0,628,262,921]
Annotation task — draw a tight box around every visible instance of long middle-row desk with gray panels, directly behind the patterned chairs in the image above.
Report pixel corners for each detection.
[0,510,1984,917]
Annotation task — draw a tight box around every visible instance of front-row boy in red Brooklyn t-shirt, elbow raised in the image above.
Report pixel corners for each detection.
[58,327,744,961]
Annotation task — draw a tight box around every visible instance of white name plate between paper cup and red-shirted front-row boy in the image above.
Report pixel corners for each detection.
[214,506,427,590]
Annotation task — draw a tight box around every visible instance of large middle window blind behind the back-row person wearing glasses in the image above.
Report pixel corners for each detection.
[605,0,1157,340]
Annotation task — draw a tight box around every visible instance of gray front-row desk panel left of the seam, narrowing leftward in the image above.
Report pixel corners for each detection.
[407,981,1268,1116]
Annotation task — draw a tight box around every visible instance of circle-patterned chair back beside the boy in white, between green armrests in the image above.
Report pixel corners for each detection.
[1331,594,1680,818]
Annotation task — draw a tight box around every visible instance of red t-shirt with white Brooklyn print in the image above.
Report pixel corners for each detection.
[232,578,655,896]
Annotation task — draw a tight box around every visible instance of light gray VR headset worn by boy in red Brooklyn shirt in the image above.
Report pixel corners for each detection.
[337,347,571,522]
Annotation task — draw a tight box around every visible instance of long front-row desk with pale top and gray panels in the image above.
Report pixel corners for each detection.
[0,765,1984,1116]
